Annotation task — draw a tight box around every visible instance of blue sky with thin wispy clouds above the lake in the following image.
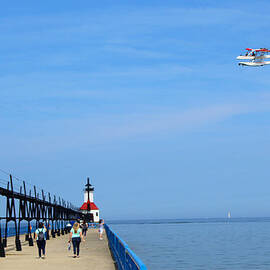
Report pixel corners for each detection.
[0,0,270,219]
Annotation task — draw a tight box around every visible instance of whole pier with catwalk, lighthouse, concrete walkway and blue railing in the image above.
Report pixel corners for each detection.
[0,173,146,270]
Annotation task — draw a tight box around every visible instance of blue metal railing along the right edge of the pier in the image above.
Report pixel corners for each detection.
[105,224,147,270]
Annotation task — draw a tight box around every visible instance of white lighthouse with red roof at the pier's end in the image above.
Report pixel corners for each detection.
[80,177,99,222]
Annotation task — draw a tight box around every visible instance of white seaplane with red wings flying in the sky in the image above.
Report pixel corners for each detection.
[236,48,270,67]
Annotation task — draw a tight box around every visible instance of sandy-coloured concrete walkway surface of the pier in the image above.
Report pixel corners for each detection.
[0,229,115,270]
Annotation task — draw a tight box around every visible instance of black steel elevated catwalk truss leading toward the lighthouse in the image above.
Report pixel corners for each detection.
[0,175,84,257]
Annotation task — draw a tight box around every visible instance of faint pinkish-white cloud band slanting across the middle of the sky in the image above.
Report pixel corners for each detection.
[1,97,269,155]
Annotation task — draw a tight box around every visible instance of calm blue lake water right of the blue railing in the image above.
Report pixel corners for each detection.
[109,218,270,270]
